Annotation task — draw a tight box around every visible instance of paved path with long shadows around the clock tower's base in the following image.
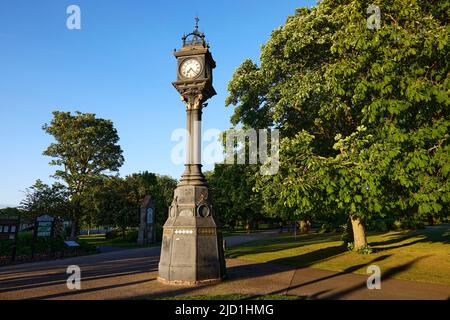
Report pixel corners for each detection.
[0,232,450,300]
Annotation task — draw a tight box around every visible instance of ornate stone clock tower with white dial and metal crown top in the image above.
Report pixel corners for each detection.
[158,18,229,285]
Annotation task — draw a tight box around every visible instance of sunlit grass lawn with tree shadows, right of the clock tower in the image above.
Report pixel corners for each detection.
[227,224,450,285]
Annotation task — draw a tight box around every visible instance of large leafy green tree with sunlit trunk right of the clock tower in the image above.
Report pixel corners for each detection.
[226,0,450,249]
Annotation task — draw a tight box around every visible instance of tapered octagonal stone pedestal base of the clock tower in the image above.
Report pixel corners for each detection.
[159,184,225,285]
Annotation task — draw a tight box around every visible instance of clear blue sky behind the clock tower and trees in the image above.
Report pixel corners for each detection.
[0,0,315,205]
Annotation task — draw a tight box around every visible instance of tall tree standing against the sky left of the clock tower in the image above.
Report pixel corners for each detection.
[43,111,124,237]
